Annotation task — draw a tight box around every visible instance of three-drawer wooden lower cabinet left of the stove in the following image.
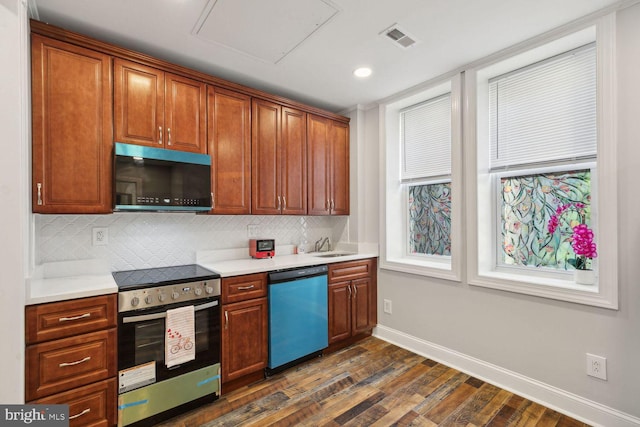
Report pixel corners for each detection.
[25,294,118,427]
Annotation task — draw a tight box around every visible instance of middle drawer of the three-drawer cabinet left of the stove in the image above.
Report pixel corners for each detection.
[26,328,117,401]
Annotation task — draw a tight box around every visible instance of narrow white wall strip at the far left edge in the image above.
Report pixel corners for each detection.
[0,0,29,403]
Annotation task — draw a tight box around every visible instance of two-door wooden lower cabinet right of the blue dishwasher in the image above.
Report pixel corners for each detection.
[329,259,377,350]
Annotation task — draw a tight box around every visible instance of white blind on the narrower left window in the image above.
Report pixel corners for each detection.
[400,93,451,181]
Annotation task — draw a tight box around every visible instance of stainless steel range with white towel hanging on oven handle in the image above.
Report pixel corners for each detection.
[113,264,220,427]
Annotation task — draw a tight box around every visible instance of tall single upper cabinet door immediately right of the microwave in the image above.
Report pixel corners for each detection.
[207,86,251,215]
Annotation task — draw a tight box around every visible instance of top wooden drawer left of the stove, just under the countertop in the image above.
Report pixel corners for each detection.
[25,294,118,344]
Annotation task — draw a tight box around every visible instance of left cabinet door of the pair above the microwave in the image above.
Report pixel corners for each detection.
[113,58,165,148]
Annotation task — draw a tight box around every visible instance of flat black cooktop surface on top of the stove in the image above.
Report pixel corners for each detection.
[113,264,220,290]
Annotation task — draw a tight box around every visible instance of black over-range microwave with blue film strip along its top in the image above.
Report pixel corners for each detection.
[113,142,211,212]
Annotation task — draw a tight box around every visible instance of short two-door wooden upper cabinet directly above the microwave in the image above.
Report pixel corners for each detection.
[114,58,207,153]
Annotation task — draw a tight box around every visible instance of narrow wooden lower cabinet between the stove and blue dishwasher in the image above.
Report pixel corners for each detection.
[221,273,269,393]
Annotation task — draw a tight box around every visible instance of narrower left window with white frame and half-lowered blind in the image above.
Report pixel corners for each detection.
[380,75,462,280]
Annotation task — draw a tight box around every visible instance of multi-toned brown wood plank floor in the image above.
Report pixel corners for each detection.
[156,337,586,427]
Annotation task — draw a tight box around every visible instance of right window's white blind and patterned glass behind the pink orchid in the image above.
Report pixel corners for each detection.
[489,43,597,271]
